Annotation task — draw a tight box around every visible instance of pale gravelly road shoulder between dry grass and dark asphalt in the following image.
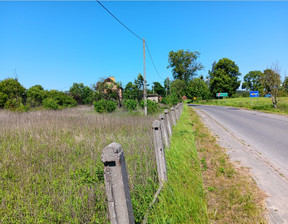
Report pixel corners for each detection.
[194,108,288,223]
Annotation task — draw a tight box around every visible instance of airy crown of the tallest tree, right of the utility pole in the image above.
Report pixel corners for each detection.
[167,50,204,83]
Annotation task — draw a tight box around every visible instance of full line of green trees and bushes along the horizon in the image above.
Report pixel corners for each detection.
[0,50,288,113]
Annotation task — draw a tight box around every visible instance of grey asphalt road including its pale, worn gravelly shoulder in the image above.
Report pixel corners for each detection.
[191,105,288,223]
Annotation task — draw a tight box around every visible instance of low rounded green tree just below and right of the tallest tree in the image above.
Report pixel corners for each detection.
[186,78,210,100]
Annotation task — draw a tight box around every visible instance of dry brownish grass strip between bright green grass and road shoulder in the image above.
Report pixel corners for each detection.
[189,106,266,223]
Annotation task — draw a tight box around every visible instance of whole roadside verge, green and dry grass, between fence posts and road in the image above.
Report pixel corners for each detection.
[148,107,266,224]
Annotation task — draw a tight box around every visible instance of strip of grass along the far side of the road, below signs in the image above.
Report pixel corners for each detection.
[193,97,288,114]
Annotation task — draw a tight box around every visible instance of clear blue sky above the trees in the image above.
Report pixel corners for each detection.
[0,1,288,90]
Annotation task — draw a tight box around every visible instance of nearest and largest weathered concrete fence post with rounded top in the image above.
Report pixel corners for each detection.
[101,142,135,224]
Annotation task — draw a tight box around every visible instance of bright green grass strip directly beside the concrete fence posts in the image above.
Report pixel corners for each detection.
[148,107,208,224]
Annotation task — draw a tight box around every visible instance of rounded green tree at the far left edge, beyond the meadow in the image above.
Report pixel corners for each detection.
[0,78,26,109]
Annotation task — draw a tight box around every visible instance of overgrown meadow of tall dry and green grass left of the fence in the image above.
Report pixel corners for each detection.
[0,107,158,223]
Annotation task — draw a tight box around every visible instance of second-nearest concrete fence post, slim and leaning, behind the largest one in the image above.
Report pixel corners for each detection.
[152,120,167,183]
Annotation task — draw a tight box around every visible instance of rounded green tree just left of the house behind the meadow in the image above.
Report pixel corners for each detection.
[69,83,93,104]
